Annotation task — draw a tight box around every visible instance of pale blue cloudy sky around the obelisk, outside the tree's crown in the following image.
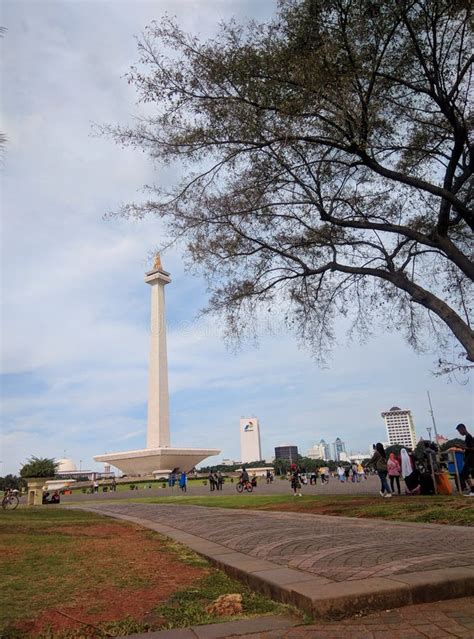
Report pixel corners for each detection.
[0,0,473,474]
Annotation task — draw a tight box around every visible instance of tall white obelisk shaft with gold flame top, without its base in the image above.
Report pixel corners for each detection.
[145,255,171,448]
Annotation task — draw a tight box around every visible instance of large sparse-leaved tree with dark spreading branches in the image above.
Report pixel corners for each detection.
[108,0,474,362]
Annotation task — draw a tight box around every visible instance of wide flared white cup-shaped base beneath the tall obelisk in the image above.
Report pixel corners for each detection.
[94,447,221,477]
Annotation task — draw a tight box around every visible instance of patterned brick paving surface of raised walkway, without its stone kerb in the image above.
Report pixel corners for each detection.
[85,504,474,584]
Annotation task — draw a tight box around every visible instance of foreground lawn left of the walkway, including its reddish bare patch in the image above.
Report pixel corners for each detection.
[0,507,287,639]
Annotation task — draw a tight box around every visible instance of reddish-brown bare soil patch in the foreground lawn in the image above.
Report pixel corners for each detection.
[15,524,207,638]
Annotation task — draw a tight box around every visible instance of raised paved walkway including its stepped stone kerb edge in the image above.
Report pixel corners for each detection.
[81,504,474,618]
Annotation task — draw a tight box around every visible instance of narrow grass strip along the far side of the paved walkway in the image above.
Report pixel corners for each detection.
[125,494,474,526]
